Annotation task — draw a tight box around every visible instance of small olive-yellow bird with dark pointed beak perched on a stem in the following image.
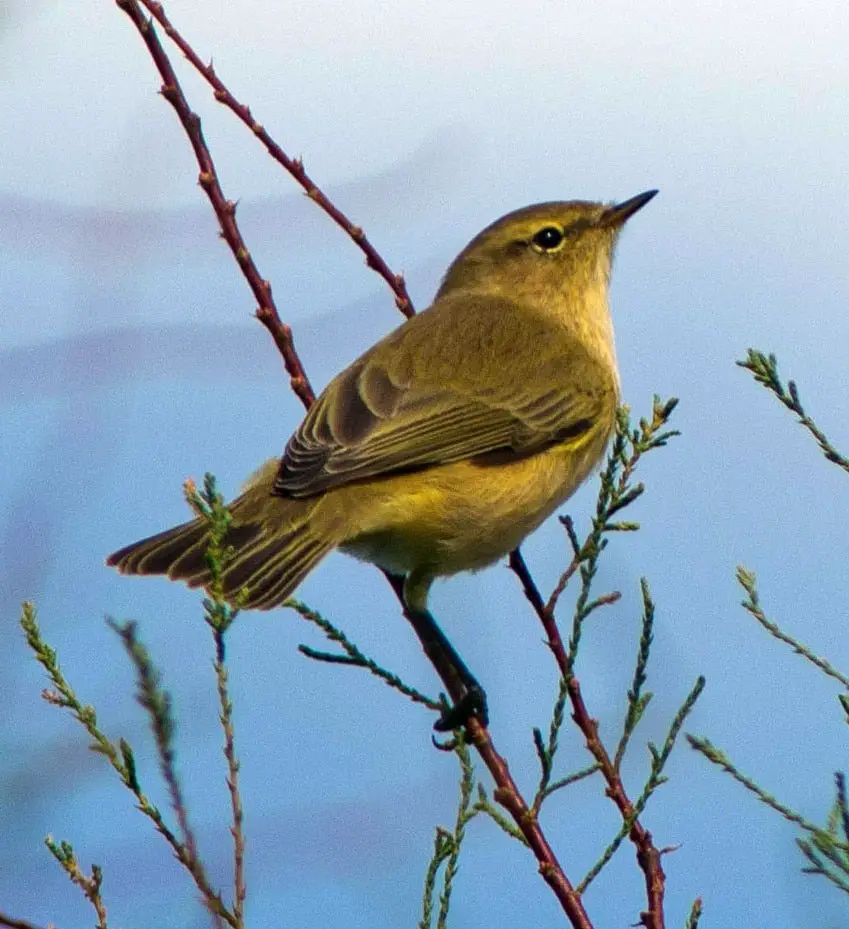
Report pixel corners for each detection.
[107,190,657,724]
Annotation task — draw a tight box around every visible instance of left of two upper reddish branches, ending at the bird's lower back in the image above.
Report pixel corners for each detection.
[116,0,315,407]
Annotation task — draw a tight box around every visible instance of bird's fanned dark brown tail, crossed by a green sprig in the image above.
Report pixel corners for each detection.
[106,478,335,610]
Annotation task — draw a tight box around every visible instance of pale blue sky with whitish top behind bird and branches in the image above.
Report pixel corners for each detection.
[0,0,849,929]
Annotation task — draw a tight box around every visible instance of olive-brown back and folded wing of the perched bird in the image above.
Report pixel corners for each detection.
[274,294,616,497]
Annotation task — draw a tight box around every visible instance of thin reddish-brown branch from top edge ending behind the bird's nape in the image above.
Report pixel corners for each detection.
[138,0,415,318]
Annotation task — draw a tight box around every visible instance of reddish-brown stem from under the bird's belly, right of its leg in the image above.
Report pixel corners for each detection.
[510,550,666,929]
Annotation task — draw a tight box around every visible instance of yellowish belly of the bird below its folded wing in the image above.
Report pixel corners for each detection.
[334,435,607,576]
